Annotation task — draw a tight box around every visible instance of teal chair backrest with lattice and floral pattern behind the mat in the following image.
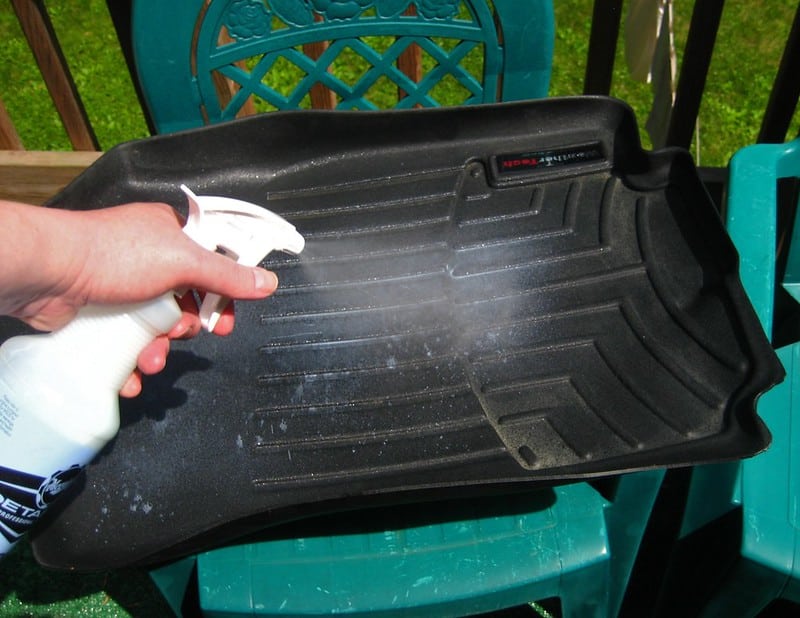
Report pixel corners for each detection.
[132,0,554,133]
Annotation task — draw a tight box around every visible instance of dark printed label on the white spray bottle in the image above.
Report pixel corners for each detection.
[0,464,81,555]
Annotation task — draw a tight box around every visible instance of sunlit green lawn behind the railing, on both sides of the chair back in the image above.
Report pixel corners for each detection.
[0,0,800,165]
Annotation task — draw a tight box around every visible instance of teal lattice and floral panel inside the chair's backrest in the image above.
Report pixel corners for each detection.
[192,0,503,122]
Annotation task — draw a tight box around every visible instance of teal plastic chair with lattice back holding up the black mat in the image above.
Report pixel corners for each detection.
[128,0,663,617]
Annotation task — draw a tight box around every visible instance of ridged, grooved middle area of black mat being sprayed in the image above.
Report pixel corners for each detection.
[242,158,743,488]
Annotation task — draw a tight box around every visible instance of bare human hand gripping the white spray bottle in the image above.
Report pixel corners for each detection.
[0,202,277,397]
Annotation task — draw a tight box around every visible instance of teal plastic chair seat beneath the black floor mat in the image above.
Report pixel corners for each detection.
[151,470,664,618]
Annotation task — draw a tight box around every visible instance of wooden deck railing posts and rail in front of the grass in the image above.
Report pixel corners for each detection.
[0,0,800,201]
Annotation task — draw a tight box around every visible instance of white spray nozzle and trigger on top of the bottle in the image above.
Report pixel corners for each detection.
[181,185,305,331]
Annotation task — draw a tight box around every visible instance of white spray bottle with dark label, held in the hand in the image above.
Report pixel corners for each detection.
[0,187,305,558]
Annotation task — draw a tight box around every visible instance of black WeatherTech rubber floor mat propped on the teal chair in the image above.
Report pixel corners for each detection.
[10,99,782,568]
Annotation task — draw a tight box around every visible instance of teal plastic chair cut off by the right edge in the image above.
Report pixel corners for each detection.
[666,139,800,616]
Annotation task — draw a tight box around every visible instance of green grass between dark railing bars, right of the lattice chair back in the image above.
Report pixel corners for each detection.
[550,0,800,166]
